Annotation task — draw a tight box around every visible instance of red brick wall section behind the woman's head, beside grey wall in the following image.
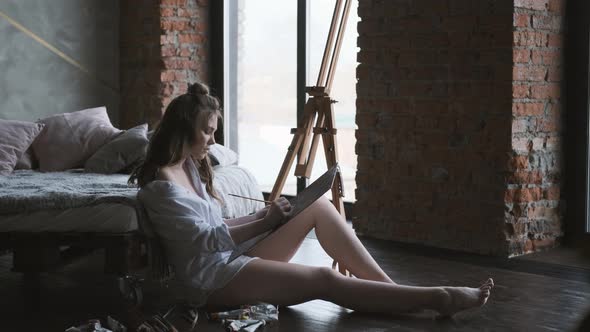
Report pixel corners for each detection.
[120,0,209,128]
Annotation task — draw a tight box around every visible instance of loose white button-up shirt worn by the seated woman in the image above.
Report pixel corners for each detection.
[138,158,254,304]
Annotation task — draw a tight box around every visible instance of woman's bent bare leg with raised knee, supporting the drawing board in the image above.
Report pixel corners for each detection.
[248,197,393,283]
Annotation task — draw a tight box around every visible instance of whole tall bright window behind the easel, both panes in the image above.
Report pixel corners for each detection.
[224,0,358,201]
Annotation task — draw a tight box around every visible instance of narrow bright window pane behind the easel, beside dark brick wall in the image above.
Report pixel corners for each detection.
[308,0,359,202]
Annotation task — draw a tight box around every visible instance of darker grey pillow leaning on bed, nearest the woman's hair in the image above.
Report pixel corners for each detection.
[84,123,148,174]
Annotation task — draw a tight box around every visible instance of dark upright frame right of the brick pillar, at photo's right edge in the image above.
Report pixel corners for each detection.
[562,1,590,246]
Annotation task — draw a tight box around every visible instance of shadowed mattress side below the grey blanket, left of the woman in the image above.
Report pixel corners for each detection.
[0,203,138,233]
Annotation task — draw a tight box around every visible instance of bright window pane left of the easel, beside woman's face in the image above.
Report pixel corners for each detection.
[237,0,297,194]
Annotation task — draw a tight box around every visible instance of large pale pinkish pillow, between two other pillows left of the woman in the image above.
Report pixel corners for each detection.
[33,107,121,172]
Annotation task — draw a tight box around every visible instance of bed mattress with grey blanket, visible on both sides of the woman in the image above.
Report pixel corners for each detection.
[0,165,264,233]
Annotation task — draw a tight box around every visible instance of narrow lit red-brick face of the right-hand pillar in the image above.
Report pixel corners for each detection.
[505,0,565,254]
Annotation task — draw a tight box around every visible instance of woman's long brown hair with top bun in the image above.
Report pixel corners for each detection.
[128,83,221,200]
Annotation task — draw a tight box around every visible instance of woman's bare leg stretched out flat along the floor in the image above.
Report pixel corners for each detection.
[207,259,493,315]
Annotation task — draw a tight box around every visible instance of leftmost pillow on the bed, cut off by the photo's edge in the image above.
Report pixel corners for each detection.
[0,120,44,175]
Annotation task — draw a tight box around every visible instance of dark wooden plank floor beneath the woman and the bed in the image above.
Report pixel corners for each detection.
[0,238,590,331]
